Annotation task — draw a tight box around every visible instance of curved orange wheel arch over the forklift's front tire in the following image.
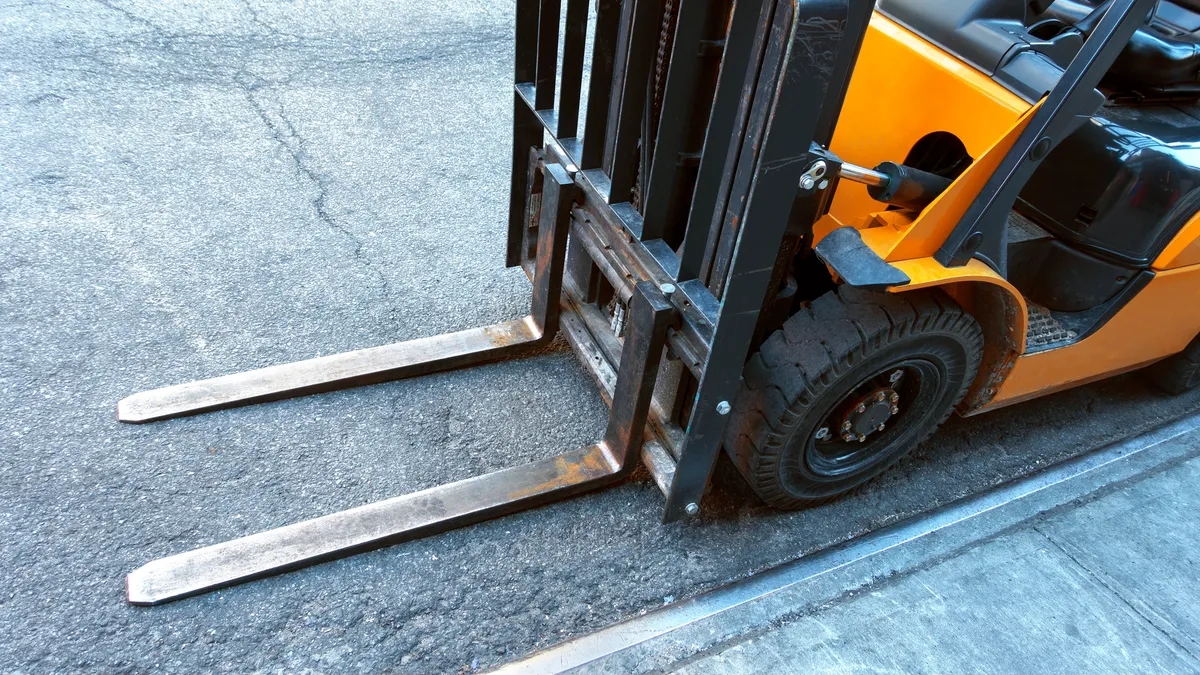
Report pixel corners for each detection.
[889,257,1030,416]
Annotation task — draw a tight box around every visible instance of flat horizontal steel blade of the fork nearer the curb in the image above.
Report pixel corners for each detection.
[126,443,623,605]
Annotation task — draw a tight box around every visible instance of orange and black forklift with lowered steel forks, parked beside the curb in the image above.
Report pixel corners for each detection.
[118,0,1200,604]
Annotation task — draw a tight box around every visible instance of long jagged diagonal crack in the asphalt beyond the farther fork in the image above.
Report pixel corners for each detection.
[234,70,396,324]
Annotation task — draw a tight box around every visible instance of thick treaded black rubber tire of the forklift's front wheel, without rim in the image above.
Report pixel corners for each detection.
[725,286,983,509]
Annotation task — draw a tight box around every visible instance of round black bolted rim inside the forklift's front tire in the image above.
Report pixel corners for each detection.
[803,358,944,480]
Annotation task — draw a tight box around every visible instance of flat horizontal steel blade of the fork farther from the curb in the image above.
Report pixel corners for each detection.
[116,316,544,423]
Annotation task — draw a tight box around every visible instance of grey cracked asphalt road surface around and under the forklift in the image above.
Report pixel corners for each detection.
[0,0,1200,673]
